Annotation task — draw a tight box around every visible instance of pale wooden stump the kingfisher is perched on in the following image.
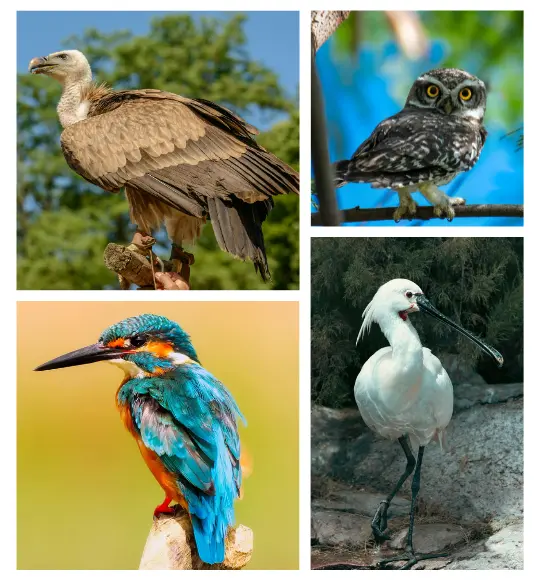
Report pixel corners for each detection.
[139,507,253,570]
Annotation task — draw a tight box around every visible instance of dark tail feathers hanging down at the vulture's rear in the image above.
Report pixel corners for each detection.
[207,198,273,282]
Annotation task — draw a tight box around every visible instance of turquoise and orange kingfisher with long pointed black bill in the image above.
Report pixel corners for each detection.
[35,314,245,564]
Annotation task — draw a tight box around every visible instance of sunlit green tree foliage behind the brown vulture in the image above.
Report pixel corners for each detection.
[17,15,299,289]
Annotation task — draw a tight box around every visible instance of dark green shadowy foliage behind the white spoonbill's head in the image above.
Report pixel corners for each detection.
[311,238,523,407]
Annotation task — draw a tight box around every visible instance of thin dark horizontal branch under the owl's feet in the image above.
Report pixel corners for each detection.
[311,204,523,226]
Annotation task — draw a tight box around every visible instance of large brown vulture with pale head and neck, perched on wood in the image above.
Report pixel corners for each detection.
[29,50,299,281]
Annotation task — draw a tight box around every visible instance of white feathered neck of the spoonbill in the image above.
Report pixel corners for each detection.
[377,312,423,368]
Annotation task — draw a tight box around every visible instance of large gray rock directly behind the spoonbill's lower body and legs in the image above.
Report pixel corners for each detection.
[312,399,523,529]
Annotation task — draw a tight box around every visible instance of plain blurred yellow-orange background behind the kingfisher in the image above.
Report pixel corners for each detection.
[17,301,298,569]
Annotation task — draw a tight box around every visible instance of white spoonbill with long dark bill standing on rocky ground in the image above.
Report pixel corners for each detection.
[354,279,503,570]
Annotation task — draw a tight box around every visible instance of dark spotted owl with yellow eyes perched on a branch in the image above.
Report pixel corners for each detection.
[334,68,487,222]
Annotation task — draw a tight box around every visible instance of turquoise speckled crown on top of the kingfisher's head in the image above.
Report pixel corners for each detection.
[99,314,199,362]
